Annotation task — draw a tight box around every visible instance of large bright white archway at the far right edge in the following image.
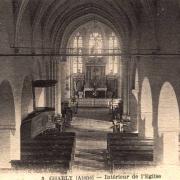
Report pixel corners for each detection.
[158,82,179,164]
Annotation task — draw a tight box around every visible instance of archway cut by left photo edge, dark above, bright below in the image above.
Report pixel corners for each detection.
[0,80,15,168]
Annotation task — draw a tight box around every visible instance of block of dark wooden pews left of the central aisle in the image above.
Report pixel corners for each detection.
[11,132,76,172]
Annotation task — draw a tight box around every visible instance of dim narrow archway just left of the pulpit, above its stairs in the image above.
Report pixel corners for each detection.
[21,76,33,119]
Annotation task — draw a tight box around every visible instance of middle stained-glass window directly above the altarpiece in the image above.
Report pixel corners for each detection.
[89,32,103,55]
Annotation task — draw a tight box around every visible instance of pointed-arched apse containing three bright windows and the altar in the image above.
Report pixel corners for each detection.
[65,20,121,99]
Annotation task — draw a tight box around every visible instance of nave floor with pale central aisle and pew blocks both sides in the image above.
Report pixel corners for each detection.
[11,108,155,173]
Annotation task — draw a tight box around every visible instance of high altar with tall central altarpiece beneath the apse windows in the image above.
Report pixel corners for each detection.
[73,57,117,99]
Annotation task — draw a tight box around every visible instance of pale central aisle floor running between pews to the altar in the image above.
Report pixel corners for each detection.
[69,108,112,172]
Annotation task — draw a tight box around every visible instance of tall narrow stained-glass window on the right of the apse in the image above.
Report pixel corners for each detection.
[109,33,118,74]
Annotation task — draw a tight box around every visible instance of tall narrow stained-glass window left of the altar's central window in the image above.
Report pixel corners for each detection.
[72,32,83,73]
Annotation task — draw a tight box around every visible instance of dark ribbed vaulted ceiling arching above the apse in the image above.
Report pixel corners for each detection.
[16,0,170,50]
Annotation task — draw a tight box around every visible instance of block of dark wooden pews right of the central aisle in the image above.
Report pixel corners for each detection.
[107,133,154,170]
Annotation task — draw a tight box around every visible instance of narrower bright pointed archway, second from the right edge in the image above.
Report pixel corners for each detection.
[141,77,154,137]
